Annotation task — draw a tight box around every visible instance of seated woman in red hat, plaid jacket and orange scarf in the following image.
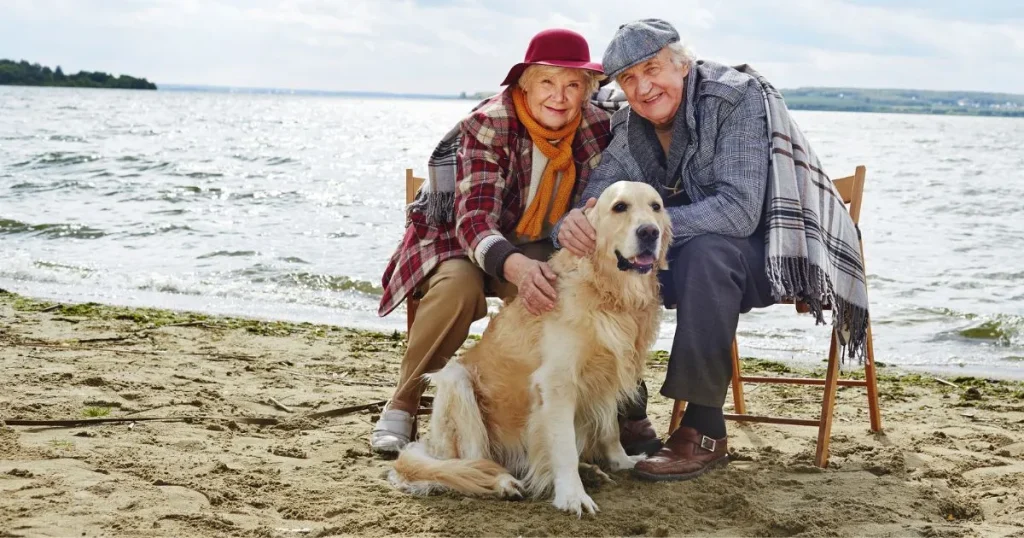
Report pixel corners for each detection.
[370,30,610,453]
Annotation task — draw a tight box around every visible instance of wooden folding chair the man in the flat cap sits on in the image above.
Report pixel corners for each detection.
[669,166,882,467]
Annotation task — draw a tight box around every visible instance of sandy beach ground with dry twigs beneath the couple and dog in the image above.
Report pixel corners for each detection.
[0,292,1024,537]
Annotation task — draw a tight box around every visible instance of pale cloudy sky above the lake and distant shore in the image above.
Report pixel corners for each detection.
[0,0,1024,94]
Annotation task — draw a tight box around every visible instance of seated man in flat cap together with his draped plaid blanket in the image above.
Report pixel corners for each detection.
[552,19,867,481]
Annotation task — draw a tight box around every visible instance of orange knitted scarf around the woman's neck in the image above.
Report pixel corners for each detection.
[512,87,583,240]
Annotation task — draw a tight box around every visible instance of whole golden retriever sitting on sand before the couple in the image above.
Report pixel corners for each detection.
[390,181,672,515]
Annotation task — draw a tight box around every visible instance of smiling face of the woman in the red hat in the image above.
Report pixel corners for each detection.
[523,69,588,130]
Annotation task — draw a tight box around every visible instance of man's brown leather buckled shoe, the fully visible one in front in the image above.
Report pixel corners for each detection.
[633,426,729,482]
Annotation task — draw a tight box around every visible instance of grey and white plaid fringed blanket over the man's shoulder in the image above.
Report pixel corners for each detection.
[736,66,868,359]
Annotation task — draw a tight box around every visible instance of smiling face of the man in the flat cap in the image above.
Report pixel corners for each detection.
[617,48,689,125]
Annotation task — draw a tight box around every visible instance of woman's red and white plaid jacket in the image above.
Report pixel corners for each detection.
[377,89,611,316]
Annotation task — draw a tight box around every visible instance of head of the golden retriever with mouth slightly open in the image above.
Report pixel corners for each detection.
[587,181,672,275]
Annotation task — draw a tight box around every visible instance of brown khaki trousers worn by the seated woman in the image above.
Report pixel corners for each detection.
[392,241,554,407]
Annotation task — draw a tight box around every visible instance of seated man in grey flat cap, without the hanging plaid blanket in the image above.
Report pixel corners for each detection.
[553,19,774,481]
